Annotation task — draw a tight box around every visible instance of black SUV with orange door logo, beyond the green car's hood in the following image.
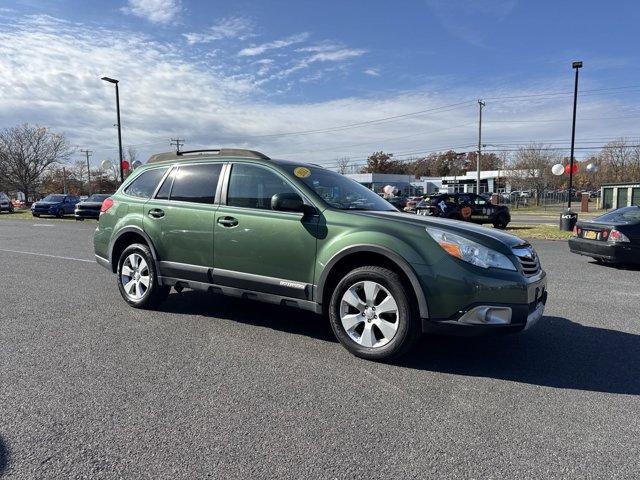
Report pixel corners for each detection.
[416,193,511,228]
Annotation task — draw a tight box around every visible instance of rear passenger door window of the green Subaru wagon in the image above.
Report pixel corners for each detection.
[170,163,222,203]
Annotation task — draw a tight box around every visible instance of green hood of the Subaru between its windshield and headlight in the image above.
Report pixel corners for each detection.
[353,211,528,253]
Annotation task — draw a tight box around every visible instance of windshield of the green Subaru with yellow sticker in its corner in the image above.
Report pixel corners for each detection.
[290,166,397,212]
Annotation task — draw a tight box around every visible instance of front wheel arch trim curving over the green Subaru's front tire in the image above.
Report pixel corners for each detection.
[314,245,429,318]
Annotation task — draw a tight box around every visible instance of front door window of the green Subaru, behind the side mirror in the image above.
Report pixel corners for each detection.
[227,163,297,210]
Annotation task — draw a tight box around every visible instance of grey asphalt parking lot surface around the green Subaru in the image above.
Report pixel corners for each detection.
[0,219,640,479]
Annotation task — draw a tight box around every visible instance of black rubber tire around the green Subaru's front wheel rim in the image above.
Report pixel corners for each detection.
[329,266,420,360]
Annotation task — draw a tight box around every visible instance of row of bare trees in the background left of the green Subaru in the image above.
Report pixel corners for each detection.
[0,123,137,201]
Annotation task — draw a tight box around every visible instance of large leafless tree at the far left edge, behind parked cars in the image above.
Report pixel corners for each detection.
[0,123,72,201]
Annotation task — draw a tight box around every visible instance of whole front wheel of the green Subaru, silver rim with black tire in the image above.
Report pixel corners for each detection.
[329,266,420,360]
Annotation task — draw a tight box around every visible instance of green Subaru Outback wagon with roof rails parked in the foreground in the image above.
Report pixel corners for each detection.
[94,149,547,359]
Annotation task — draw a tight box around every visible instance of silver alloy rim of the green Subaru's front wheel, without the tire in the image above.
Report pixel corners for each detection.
[340,280,400,348]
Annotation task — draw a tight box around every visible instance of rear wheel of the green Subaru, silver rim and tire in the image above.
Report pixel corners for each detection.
[117,243,170,308]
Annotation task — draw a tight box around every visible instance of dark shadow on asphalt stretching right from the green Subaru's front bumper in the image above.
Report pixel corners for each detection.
[395,317,640,395]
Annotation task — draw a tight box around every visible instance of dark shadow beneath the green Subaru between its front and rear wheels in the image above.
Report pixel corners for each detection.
[160,290,337,342]
